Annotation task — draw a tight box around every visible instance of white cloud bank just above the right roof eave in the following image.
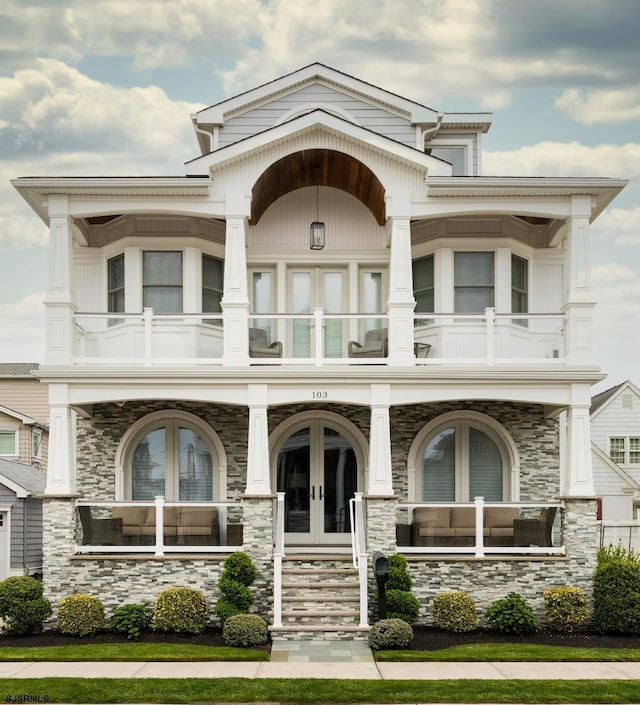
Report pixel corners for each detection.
[482,142,640,179]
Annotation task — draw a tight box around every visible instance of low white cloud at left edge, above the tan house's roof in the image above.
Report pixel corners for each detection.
[0,294,45,362]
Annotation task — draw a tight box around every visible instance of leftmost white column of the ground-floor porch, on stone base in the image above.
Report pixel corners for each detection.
[45,384,76,495]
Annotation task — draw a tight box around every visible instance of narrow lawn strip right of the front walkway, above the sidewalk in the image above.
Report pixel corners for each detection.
[376,643,640,661]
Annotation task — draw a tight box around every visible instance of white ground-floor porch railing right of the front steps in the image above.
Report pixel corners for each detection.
[396,497,565,558]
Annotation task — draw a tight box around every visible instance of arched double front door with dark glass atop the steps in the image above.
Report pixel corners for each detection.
[277,421,358,545]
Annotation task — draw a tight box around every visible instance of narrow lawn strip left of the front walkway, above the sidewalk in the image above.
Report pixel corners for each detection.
[0,641,269,660]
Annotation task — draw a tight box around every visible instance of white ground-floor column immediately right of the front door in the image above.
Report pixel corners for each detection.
[367,384,394,497]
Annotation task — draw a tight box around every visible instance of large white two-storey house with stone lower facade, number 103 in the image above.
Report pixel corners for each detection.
[14,64,626,635]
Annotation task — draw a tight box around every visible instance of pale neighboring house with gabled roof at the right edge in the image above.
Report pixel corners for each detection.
[591,380,640,522]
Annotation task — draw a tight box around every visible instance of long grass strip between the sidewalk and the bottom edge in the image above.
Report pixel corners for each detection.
[0,678,640,704]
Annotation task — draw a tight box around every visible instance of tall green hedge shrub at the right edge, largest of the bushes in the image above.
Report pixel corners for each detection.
[593,546,640,634]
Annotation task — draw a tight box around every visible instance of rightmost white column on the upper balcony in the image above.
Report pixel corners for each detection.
[563,196,595,364]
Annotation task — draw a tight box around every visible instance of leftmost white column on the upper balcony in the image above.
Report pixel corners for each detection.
[44,195,74,365]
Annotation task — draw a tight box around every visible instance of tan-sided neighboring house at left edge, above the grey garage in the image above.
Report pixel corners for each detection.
[0,362,49,470]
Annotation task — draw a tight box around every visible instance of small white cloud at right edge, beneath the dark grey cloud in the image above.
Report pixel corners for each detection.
[555,85,640,125]
